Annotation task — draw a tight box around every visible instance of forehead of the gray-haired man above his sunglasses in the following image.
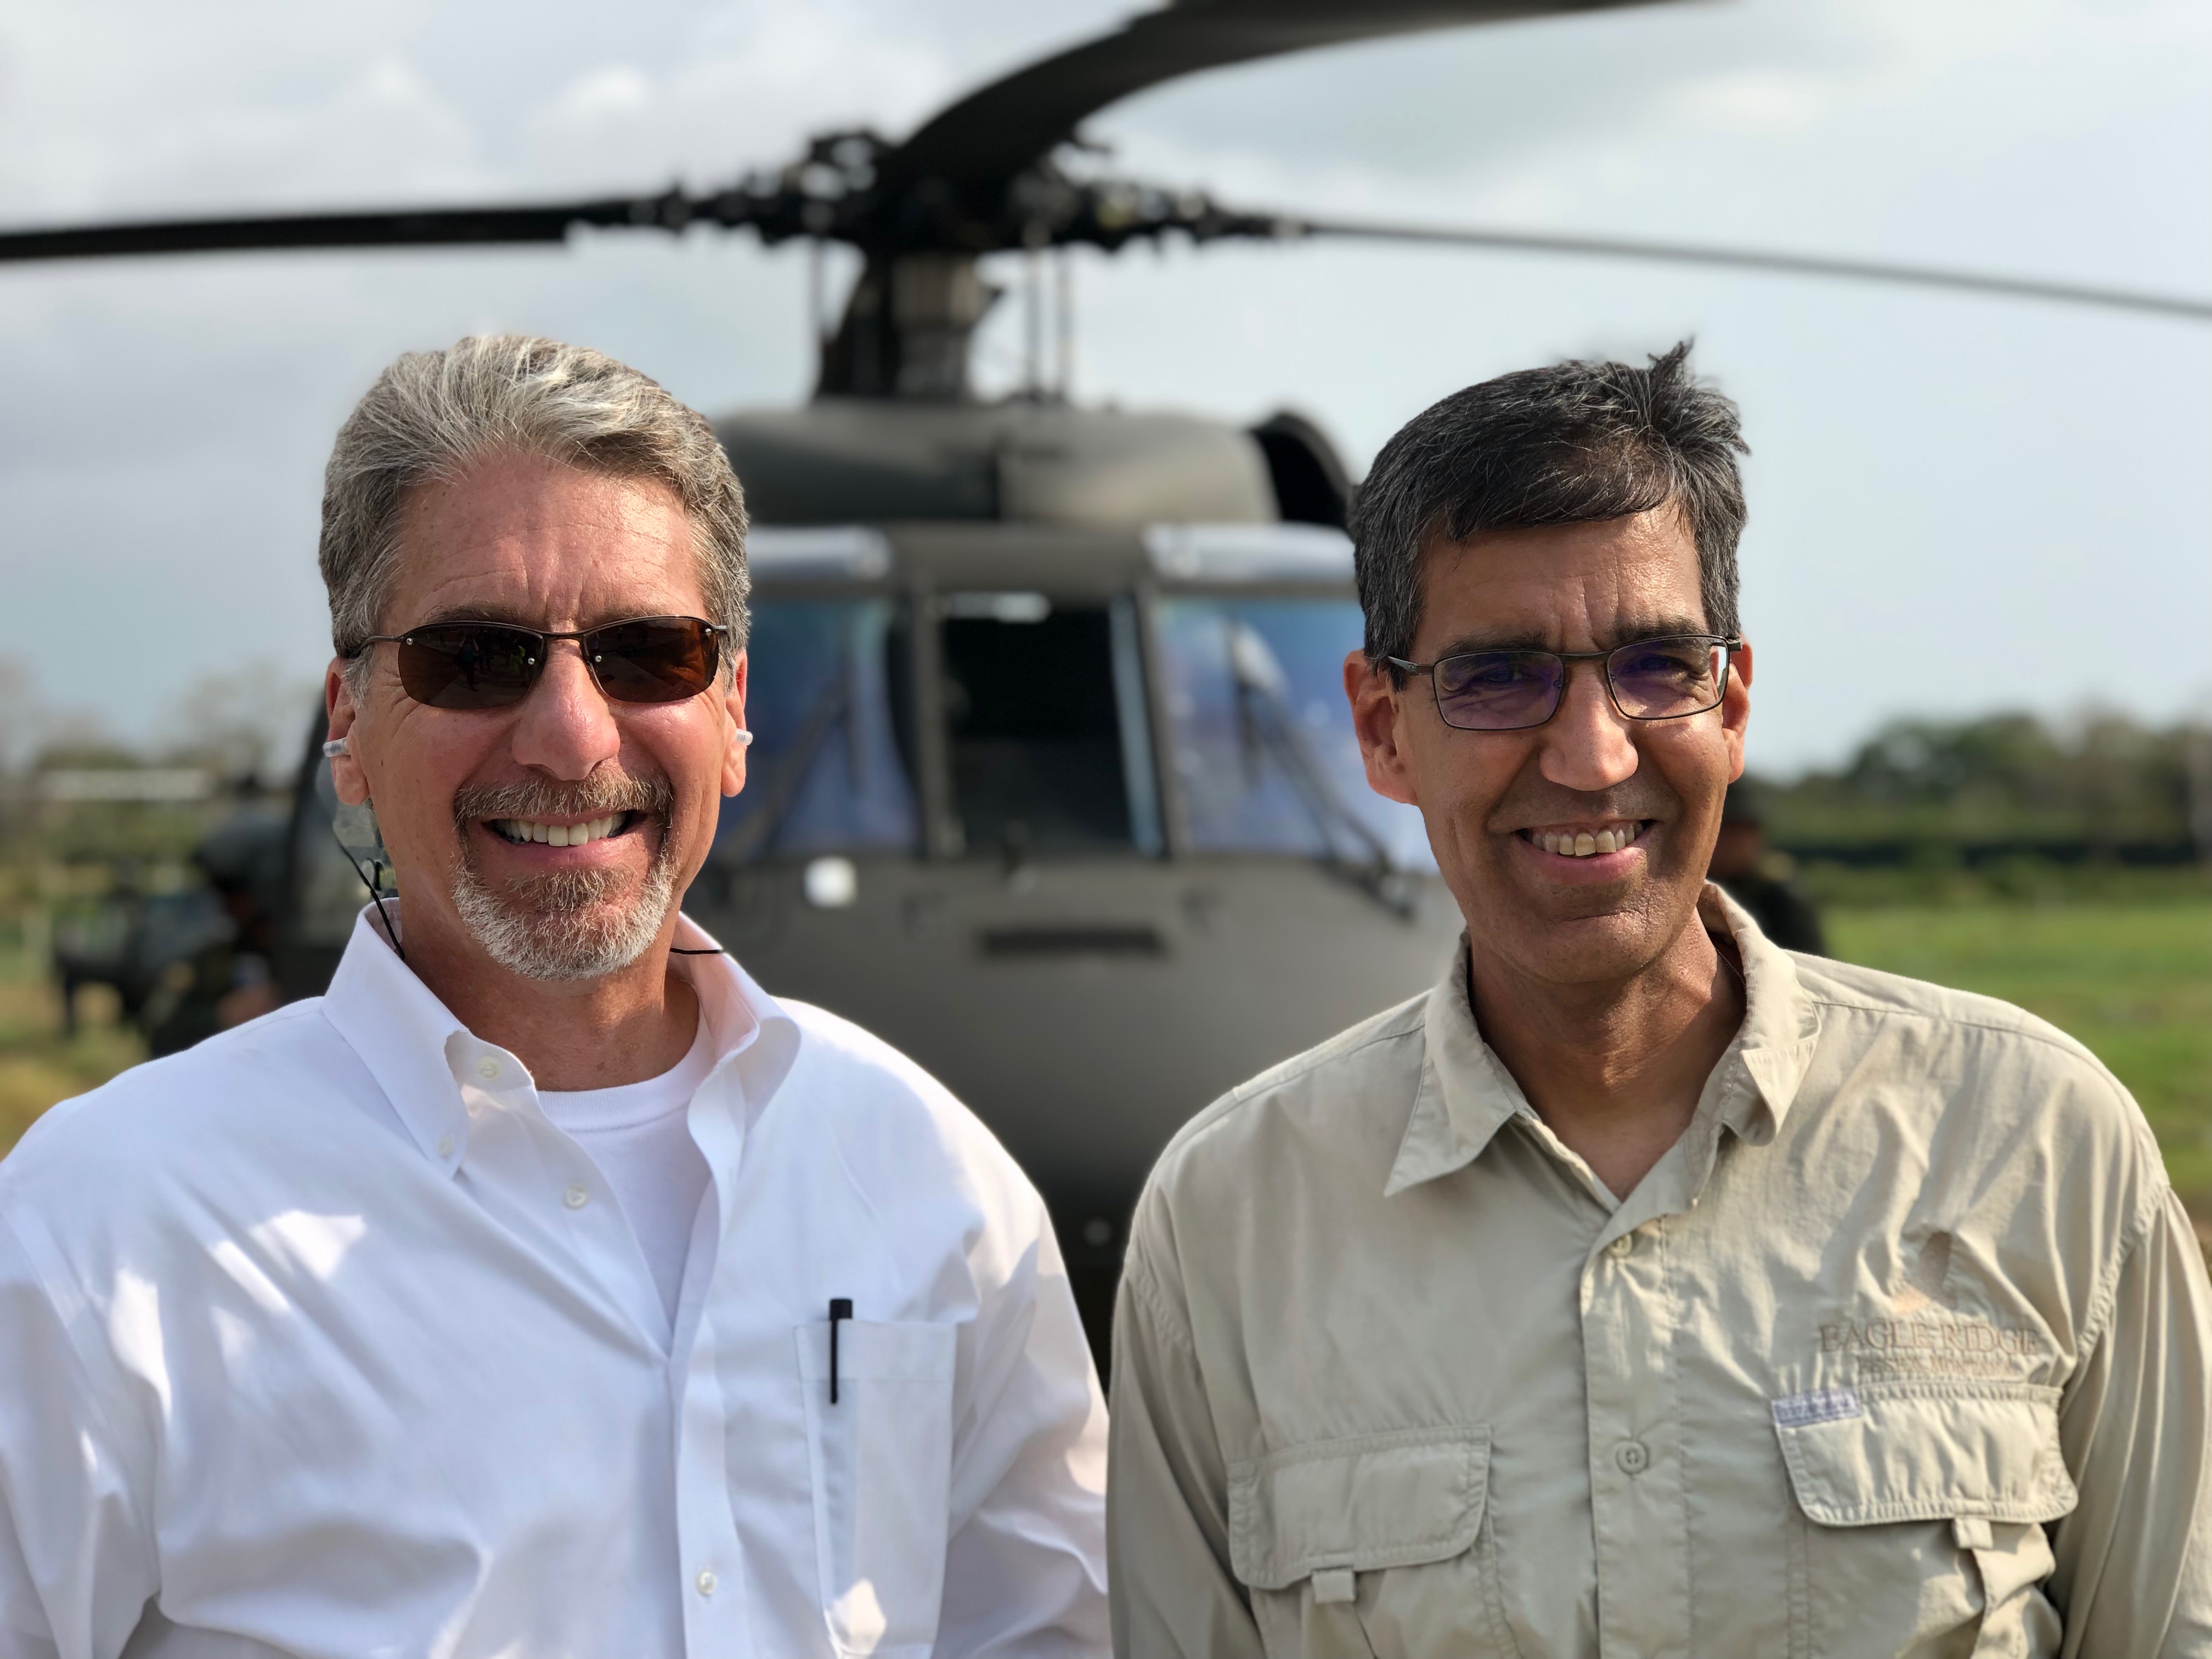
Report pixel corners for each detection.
[383,456,706,628]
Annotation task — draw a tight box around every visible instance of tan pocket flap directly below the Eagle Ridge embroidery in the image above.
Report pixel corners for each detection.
[1774,1380,2079,1526]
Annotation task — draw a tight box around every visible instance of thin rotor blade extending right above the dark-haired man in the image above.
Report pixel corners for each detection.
[1276,217,2212,323]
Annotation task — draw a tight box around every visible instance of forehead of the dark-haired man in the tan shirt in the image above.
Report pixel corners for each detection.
[1415,506,1708,659]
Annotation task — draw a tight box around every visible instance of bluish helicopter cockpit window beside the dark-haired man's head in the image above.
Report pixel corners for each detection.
[1155,597,1436,870]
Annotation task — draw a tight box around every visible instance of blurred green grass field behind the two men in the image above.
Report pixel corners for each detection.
[0,911,2212,1221]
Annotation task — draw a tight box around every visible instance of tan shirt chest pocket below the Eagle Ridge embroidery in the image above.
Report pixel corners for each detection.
[1774,1380,2079,1659]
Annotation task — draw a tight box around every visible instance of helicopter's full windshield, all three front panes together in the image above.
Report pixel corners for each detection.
[719,593,1436,870]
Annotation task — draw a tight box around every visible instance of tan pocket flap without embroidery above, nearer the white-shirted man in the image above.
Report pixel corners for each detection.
[1230,1427,1491,1590]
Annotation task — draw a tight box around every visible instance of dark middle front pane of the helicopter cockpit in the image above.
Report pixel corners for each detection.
[938,593,1161,860]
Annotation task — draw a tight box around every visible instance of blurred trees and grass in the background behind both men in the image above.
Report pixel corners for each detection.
[0,664,2212,1234]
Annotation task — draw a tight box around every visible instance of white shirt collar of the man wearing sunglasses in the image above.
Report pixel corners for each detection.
[323,900,799,1170]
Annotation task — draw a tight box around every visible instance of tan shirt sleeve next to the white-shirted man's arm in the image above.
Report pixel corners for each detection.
[1106,1223,1263,1659]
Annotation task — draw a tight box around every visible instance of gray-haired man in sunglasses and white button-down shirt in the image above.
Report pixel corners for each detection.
[0,338,1106,1659]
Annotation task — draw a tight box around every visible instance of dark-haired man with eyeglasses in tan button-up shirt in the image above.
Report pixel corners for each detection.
[1108,347,2212,1659]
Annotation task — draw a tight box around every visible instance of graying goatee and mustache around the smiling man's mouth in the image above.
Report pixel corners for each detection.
[454,776,677,980]
